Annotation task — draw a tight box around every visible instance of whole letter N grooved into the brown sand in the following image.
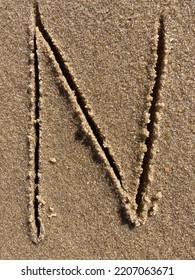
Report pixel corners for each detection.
[28,3,165,236]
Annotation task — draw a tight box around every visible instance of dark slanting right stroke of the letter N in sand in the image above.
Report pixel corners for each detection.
[136,16,166,219]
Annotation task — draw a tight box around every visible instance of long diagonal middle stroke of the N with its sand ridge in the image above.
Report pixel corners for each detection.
[33,5,140,228]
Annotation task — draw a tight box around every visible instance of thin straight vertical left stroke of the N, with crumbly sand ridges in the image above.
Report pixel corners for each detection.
[29,4,45,244]
